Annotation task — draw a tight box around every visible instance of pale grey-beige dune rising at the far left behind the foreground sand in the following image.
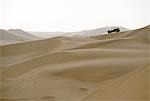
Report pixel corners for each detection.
[0,29,40,46]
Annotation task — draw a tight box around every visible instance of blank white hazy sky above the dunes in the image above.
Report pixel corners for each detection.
[0,0,150,31]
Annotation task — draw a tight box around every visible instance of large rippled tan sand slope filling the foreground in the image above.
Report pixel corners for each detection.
[0,26,150,101]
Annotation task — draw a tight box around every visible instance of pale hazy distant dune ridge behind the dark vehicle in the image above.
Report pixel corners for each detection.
[29,26,129,38]
